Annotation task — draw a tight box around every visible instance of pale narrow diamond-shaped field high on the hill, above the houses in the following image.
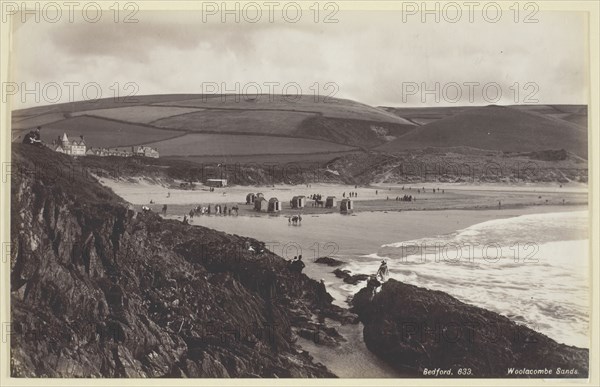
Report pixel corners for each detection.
[72,105,200,124]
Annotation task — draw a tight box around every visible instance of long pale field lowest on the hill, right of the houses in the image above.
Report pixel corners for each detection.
[143,133,353,156]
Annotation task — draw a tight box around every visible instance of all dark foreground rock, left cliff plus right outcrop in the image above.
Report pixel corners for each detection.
[11,144,588,378]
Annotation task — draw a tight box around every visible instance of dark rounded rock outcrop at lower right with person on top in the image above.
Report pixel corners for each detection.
[352,280,589,378]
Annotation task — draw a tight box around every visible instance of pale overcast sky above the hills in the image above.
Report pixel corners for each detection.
[11,11,588,108]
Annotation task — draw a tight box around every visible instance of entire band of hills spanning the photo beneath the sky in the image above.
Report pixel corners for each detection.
[12,94,587,163]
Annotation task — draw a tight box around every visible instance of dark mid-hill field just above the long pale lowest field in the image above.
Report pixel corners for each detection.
[152,108,313,135]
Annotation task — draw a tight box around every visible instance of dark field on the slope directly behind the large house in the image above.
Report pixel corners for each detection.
[37,117,181,148]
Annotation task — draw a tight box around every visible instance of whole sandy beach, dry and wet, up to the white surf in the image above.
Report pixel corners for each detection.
[103,180,587,377]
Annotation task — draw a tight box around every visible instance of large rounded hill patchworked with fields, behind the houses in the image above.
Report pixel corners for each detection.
[12,94,415,161]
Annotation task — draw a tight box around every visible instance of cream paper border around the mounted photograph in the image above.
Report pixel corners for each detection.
[0,0,600,387]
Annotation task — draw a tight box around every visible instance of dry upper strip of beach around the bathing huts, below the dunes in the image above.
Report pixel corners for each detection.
[100,179,588,217]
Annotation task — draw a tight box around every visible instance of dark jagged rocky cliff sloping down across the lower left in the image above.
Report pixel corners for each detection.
[11,144,352,377]
